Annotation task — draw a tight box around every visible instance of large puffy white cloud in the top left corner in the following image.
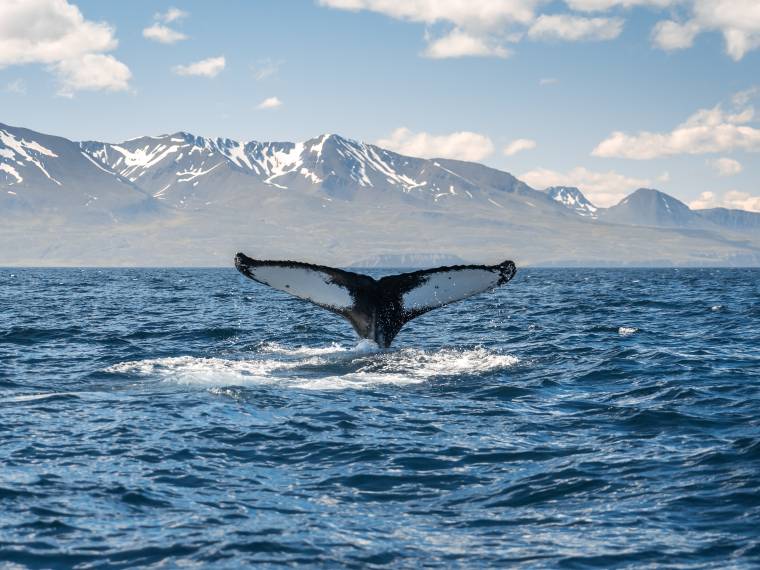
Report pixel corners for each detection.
[0,0,131,96]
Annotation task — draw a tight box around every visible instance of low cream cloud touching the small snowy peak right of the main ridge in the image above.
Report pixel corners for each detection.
[519,166,652,208]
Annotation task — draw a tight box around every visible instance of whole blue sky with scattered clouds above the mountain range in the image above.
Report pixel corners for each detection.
[0,0,760,211]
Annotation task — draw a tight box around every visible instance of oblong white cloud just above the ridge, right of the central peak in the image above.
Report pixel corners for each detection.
[377,127,494,162]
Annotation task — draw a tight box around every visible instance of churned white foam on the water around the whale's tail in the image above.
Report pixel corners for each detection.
[106,342,519,390]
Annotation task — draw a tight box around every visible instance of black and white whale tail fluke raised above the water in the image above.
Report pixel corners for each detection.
[235,253,517,348]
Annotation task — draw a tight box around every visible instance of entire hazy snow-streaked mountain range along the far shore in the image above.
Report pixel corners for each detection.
[0,123,760,266]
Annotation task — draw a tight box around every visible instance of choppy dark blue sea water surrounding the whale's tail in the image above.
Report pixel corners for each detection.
[0,269,760,568]
